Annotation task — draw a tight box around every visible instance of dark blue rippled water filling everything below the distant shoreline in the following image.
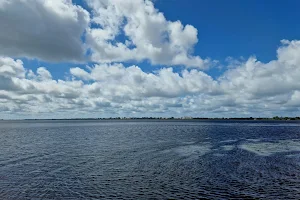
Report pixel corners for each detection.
[0,121,300,200]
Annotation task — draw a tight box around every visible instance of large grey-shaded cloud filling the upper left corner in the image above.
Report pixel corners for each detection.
[0,0,90,62]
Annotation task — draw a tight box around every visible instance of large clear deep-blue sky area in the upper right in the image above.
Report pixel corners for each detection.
[155,0,300,61]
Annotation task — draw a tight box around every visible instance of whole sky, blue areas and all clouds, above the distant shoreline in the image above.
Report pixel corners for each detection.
[0,0,300,119]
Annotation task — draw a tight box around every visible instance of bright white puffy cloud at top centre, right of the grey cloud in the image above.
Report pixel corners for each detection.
[87,0,210,68]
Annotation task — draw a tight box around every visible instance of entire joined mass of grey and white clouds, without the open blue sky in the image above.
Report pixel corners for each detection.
[0,0,300,118]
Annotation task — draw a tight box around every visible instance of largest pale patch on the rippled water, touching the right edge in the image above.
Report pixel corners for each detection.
[239,140,300,156]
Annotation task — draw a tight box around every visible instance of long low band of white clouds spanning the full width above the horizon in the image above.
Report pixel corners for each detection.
[0,41,300,117]
